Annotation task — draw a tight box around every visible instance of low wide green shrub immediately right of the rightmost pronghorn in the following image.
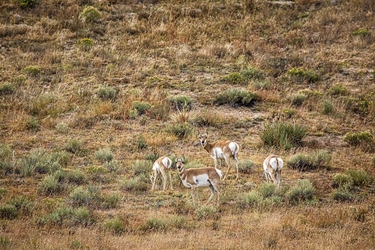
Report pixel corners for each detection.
[287,150,332,171]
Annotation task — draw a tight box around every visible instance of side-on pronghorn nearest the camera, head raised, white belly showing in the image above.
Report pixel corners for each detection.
[175,156,223,206]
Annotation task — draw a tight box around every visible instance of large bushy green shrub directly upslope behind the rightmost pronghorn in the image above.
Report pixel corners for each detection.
[260,123,307,150]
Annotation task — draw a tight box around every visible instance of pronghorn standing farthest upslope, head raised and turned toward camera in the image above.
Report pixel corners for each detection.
[198,132,240,180]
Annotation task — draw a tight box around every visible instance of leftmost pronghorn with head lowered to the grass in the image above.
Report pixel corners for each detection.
[150,156,173,191]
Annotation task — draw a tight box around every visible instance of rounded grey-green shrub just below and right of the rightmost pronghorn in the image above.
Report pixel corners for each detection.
[285,180,316,205]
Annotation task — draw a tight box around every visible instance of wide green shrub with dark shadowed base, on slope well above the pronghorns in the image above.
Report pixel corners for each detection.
[214,89,260,107]
